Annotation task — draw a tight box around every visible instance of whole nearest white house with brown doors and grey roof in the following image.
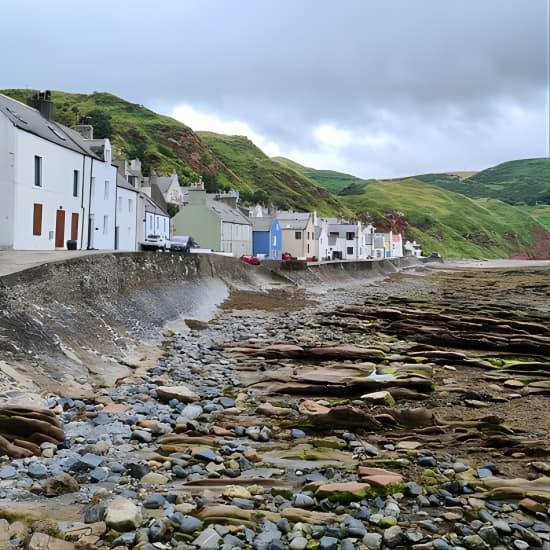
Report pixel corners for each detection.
[0,93,94,250]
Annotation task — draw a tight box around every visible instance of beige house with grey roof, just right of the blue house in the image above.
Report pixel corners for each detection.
[277,212,318,259]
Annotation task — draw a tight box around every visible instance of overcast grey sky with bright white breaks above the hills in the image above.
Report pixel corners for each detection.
[0,0,550,178]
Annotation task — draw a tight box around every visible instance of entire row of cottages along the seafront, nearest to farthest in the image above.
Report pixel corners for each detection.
[0,92,420,260]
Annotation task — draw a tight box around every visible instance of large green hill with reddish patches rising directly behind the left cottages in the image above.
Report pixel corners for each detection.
[0,90,347,215]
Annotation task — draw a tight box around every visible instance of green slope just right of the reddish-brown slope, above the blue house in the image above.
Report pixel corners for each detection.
[199,132,349,215]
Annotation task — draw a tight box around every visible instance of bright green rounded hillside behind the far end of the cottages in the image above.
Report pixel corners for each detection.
[342,179,545,258]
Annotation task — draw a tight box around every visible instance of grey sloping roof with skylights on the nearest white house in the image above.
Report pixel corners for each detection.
[0,94,102,160]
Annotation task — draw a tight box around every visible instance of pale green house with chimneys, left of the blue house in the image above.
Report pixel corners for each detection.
[172,185,252,257]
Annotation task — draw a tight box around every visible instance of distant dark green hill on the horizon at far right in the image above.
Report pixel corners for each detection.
[414,158,550,205]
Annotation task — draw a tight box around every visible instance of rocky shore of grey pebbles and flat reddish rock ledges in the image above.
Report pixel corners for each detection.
[0,267,550,550]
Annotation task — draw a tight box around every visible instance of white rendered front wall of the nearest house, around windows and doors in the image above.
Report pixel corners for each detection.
[13,130,84,250]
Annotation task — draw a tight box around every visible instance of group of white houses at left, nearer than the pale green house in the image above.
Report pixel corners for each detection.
[0,92,170,250]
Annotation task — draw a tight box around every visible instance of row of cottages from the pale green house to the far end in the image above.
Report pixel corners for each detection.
[172,187,421,261]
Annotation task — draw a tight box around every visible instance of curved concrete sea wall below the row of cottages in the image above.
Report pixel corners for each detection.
[0,252,422,394]
